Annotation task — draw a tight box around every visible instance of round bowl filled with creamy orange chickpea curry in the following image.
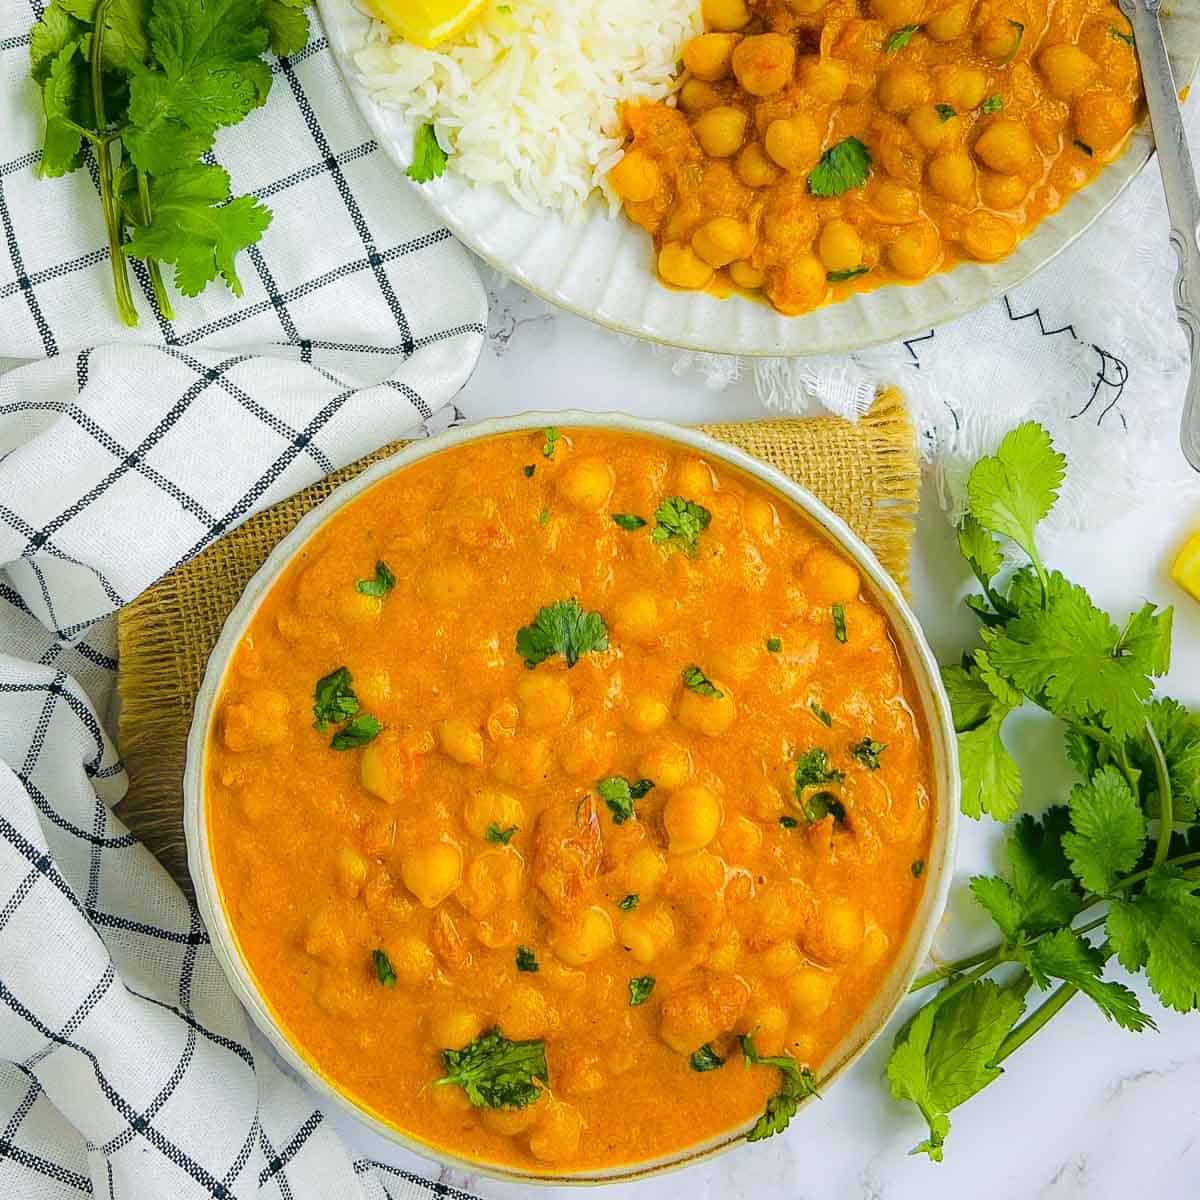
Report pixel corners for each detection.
[187,418,956,1178]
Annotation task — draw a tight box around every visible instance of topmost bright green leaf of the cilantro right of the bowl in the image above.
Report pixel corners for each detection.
[967,421,1067,575]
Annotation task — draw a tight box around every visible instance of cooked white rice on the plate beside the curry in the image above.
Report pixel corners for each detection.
[355,0,702,220]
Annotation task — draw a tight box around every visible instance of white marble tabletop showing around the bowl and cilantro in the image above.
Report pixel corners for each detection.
[330,274,1200,1200]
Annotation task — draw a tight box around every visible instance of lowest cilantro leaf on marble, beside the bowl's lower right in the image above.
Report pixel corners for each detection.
[887,979,1025,1163]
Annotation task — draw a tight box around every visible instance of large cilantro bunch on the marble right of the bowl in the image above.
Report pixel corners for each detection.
[887,424,1200,1162]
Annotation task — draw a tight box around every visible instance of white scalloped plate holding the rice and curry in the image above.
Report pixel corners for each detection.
[317,0,1200,355]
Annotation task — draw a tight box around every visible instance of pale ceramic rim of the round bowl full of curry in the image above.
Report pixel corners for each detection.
[184,409,960,1187]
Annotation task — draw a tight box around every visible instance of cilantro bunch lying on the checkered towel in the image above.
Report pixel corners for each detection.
[30,0,308,325]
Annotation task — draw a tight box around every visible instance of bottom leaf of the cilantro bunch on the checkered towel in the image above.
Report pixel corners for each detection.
[124,163,271,296]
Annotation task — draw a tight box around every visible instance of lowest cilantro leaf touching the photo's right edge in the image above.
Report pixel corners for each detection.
[1106,868,1200,1013]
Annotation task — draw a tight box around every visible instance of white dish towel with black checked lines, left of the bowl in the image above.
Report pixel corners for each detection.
[0,0,486,1200]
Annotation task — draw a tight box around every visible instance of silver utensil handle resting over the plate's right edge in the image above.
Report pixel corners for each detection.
[1118,0,1200,470]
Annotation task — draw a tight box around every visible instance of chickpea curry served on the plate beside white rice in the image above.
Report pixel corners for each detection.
[610,0,1141,316]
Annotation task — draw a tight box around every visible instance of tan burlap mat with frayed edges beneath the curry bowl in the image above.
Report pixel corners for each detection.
[118,391,919,890]
